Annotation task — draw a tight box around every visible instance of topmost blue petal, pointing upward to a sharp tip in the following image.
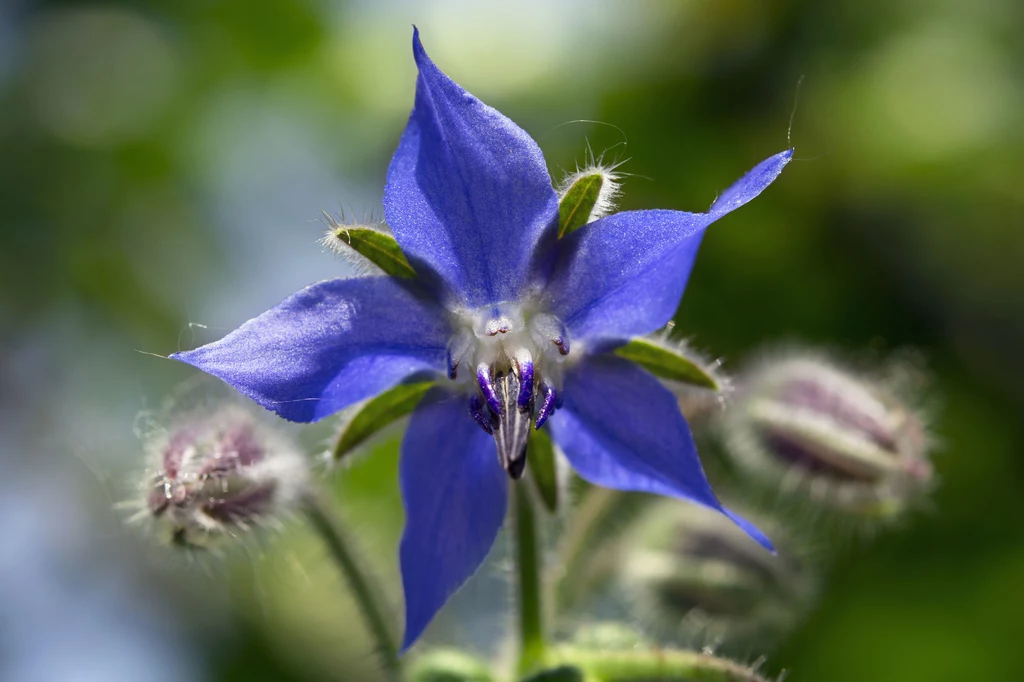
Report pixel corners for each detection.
[384,32,558,306]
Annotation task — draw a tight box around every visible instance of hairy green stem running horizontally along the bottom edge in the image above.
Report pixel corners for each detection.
[553,647,765,682]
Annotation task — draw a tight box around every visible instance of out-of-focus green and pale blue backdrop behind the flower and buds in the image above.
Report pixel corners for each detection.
[0,0,1024,682]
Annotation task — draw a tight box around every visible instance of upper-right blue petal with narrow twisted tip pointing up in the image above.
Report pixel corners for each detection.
[546,151,793,344]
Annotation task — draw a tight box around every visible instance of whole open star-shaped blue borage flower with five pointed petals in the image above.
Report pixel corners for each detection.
[174,33,792,648]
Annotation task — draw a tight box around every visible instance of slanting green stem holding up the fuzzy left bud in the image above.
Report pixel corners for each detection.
[306,495,401,681]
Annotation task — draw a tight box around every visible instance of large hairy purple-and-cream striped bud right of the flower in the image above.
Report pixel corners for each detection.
[723,354,932,518]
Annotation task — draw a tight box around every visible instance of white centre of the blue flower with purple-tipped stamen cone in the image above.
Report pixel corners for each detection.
[449,306,569,478]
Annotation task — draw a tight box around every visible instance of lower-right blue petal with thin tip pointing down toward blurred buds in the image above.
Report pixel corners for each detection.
[549,355,771,550]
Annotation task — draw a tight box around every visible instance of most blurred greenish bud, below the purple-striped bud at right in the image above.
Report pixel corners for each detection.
[620,500,813,650]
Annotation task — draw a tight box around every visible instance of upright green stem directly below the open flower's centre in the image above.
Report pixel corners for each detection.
[512,481,547,676]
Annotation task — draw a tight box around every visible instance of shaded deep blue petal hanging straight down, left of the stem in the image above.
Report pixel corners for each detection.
[399,389,508,651]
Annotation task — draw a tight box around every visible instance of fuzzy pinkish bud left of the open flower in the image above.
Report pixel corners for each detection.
[140,404,309,548]
